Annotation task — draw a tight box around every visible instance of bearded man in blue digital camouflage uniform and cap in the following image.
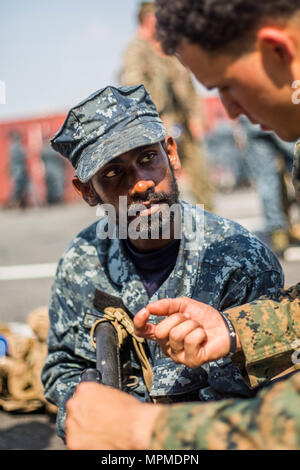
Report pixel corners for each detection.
[42,85,283,437]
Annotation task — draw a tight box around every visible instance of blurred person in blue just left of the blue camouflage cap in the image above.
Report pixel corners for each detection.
[41,134,65,205]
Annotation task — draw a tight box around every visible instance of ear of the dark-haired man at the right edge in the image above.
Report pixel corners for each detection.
[258,27,296,65]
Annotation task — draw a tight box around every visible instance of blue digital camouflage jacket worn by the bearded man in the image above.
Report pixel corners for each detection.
[42,202,284,438]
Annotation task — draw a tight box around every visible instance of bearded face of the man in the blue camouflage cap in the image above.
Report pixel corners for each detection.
[92,139,179,239]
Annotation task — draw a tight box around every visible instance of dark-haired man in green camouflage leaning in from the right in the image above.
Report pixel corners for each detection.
[63,0,300,449]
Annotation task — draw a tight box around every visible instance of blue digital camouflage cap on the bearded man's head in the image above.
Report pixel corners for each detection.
[51,85,166,183]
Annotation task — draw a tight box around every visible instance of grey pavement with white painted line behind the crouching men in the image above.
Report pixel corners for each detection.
[0,189,300,450]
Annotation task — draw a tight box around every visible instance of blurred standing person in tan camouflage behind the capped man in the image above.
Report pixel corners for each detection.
[120,2,213,210]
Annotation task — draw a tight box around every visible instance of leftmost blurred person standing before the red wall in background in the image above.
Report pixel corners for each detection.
[8,131,29,209]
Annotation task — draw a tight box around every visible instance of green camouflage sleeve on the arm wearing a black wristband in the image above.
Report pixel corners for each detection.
[225,284,300,387]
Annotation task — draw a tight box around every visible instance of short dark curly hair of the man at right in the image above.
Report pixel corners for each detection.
[156,0,300,55]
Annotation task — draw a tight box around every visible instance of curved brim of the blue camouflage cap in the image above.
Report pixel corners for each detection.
[76,121,167,183]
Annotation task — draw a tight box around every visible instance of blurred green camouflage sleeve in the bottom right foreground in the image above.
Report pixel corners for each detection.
[150,372,300,450]
